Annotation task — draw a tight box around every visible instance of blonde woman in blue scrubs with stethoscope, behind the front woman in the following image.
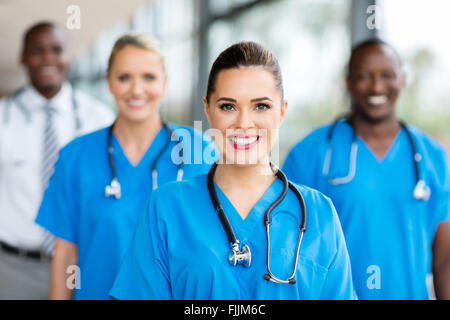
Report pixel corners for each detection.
[36,34,211,299]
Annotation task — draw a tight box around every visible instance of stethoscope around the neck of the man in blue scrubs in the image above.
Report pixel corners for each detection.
[322,117,430,201]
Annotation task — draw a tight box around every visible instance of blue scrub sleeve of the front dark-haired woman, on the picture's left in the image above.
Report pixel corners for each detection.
[110,192,172,300]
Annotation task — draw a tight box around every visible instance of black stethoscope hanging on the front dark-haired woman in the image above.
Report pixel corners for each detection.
[207,163,306,284]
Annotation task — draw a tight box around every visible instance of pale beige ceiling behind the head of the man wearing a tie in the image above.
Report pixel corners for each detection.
[0,0,152,96]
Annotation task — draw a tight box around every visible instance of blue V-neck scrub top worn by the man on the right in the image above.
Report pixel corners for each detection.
[283,122,450,299]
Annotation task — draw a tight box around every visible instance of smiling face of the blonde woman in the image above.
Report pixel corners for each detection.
[107,45,166,122]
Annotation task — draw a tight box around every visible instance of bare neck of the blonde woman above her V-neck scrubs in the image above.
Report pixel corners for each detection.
[113,114,162,153]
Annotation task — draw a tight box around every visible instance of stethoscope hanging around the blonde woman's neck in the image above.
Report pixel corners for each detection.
[105,122,184,199]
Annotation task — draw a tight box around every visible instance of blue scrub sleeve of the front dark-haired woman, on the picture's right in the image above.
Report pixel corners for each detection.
[320,200,357,300]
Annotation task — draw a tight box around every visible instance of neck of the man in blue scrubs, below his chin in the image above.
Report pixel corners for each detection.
[350,114,400,141]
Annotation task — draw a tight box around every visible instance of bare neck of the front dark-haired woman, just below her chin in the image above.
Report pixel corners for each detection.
[214,162,275,191]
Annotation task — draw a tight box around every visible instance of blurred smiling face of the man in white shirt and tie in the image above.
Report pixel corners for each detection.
[22,26,69,98]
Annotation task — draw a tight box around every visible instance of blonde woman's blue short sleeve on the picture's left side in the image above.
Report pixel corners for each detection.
[35,148,78,243]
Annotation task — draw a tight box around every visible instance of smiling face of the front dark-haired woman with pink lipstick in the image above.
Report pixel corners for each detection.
[203,67,287,165]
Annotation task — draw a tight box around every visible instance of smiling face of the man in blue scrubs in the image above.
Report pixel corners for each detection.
[347,44,405,123]
